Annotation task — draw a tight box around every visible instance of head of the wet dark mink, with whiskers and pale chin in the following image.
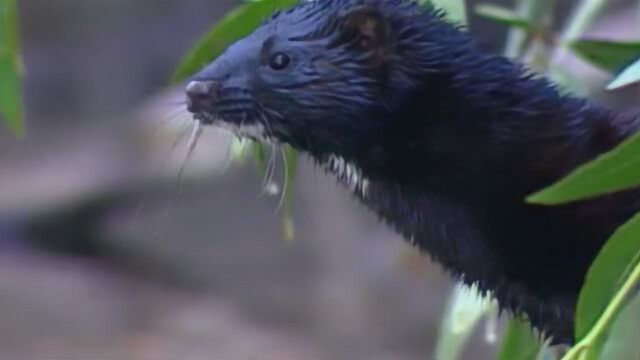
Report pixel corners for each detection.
[186,0,467,157]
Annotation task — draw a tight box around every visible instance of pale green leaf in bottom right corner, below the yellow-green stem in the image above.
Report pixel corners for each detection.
[598,296,640,360]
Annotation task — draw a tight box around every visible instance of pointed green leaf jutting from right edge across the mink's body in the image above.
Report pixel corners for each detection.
[527,133,640,205]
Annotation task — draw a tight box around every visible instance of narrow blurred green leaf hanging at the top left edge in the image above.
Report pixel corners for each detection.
[0,0,24,136]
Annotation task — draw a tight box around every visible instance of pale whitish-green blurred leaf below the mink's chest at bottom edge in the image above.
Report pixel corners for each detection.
[434,284,495,360]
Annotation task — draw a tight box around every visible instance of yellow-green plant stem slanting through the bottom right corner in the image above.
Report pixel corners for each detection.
[562,263,640,360]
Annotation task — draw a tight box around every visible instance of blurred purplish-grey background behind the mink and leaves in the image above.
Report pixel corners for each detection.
[0,0,640,360]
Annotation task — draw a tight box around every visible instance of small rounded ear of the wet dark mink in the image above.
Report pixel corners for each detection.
[340,5,391,50]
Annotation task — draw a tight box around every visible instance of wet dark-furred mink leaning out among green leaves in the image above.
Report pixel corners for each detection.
[180,0,640,344]
